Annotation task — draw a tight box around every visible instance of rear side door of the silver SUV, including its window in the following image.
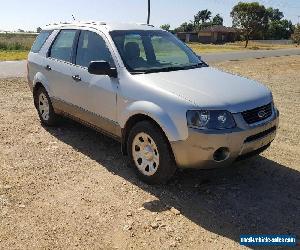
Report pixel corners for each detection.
[44,30,79,104]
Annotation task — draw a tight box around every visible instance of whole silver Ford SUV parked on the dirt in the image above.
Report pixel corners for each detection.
[28,22,279,183]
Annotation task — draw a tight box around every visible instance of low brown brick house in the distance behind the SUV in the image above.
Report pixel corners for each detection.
[176,25,239,43]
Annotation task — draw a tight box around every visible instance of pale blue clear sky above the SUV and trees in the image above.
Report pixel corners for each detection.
[0,0,300,30]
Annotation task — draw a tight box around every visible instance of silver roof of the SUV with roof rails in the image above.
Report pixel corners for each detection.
[43,21,158,31]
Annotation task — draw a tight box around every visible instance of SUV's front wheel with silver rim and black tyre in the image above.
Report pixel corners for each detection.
[127,121,177,184]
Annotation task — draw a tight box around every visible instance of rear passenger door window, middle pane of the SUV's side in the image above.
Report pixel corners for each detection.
[50,30,77,62]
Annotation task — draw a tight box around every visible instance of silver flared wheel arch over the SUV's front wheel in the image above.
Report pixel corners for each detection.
[120,101,180,142]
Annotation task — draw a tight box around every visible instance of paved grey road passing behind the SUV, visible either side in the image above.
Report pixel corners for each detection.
[0,48,300,78]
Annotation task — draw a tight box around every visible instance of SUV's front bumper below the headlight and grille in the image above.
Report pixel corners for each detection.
[171,110,279,169]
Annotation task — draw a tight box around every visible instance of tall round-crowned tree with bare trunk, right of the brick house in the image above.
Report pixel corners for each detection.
[230,2,268,48]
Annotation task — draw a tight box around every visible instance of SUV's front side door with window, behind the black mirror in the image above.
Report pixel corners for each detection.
[72,31,118,134]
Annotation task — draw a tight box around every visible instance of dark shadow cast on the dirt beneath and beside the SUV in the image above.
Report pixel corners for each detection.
[47,120,300,247]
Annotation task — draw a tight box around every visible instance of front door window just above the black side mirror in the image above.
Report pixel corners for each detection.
[76,31,114,67]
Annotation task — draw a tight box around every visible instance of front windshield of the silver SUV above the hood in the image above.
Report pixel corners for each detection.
[110,30,204,73]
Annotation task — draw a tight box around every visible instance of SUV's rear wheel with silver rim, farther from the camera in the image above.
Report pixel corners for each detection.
[34,87,58,126]
